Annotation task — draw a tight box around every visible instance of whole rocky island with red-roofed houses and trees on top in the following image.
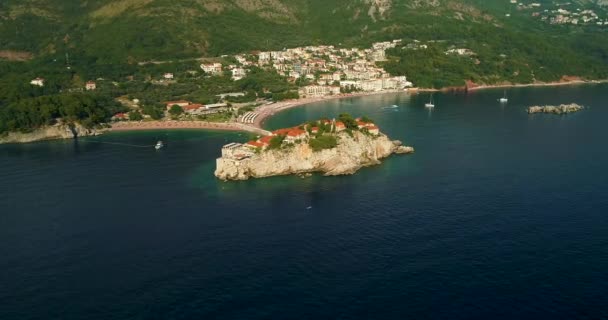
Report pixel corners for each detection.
[215,114,414,181]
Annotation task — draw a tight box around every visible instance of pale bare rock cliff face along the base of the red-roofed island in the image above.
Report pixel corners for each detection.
[215,132,414,180]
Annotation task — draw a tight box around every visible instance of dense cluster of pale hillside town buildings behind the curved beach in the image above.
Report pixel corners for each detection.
[201,40,412,98]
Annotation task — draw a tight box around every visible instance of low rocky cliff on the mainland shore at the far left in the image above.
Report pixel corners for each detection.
[0,124,102,143]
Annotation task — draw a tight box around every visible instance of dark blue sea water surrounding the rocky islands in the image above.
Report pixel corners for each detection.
[0,85,608,320]
